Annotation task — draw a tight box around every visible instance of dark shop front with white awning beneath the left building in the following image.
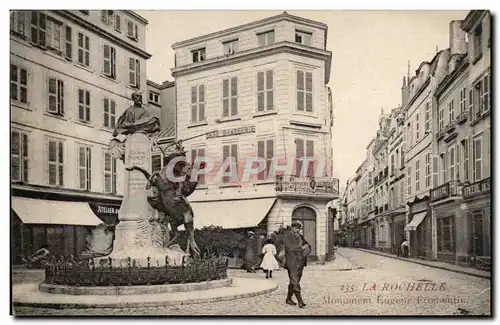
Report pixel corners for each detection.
[11,189,120,265]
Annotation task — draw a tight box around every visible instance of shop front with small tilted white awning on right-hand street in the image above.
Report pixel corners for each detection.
[405,196,433,259]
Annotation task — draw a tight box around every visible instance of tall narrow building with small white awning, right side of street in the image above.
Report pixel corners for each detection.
[404,49,450,258]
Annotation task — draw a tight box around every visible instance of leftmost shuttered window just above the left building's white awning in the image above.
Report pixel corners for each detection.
[10,130,29,182]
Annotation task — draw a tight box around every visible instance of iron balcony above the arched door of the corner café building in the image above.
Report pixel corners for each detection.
[274,176,339,199]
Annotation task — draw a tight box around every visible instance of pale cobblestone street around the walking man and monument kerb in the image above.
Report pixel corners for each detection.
[13,248,491,316]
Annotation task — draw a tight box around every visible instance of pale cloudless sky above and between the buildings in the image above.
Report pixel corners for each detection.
[137,10,468,186]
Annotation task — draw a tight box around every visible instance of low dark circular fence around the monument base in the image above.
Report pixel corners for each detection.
[44,256,228,286]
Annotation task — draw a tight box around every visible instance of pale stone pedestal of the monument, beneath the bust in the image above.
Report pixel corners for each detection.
[96,133,185,267]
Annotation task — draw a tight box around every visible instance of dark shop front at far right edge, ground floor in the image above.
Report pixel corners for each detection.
[461,178,491,269]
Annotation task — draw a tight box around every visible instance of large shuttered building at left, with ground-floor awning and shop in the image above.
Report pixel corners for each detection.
[10,10,150,263]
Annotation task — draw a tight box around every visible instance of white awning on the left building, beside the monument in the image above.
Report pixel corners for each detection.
[12,197,102,226]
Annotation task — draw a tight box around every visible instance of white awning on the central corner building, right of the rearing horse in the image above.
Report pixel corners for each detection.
[188,198,276,230]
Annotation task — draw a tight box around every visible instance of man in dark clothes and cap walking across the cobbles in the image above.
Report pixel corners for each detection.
[282,222,311,308]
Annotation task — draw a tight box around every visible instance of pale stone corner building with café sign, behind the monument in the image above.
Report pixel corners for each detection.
[172,12,338,260]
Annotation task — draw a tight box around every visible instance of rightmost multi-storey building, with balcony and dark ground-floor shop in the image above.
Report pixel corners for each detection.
[431,11,491,265]
